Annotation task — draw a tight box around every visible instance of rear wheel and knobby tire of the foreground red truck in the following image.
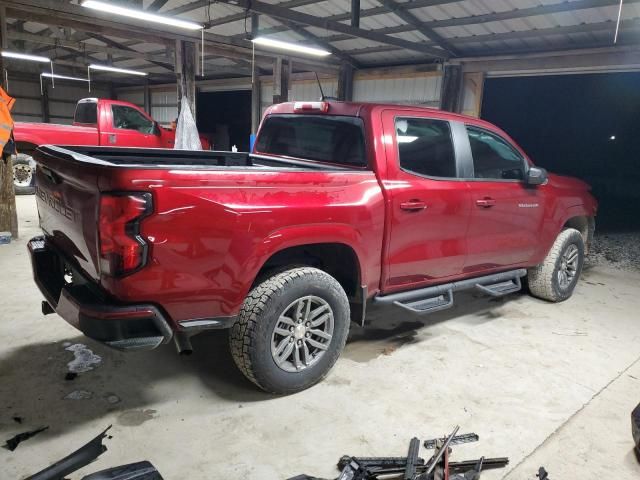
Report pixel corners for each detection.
[229,267,350,394]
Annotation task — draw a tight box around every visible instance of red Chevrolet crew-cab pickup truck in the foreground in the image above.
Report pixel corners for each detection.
[29,102,597,393]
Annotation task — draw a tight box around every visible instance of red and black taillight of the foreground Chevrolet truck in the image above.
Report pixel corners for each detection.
[98,193,153,276]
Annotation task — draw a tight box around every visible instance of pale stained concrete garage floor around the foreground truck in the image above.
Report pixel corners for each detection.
[0,197,640,480]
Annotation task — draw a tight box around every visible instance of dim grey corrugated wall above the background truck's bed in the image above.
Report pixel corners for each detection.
[9,75,109,124]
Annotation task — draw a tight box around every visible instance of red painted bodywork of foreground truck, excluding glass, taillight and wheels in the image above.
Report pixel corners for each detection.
[33,102,596,326]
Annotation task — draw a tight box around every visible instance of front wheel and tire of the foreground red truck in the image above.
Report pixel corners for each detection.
[527,228,584,302]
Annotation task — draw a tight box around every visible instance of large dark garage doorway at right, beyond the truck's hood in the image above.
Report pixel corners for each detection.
[482,73,640,232]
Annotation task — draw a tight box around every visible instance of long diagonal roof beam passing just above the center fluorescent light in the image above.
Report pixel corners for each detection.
[221,0,448,58]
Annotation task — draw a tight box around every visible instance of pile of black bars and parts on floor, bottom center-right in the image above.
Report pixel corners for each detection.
[289,427,509,480]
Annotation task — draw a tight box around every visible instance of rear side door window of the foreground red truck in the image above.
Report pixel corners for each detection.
[395,117,456,178]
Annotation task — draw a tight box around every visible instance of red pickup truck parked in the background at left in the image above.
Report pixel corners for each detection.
[13,98,210,194]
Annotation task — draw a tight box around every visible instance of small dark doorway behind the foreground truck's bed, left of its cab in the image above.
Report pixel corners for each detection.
[196,90,251,152]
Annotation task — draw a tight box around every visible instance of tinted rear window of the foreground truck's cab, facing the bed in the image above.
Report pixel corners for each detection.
[255,114,367,167]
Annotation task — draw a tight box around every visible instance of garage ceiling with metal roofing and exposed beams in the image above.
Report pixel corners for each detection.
[0,0,640,83]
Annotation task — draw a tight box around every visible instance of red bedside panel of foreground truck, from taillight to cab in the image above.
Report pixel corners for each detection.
[99,167,384,321]
